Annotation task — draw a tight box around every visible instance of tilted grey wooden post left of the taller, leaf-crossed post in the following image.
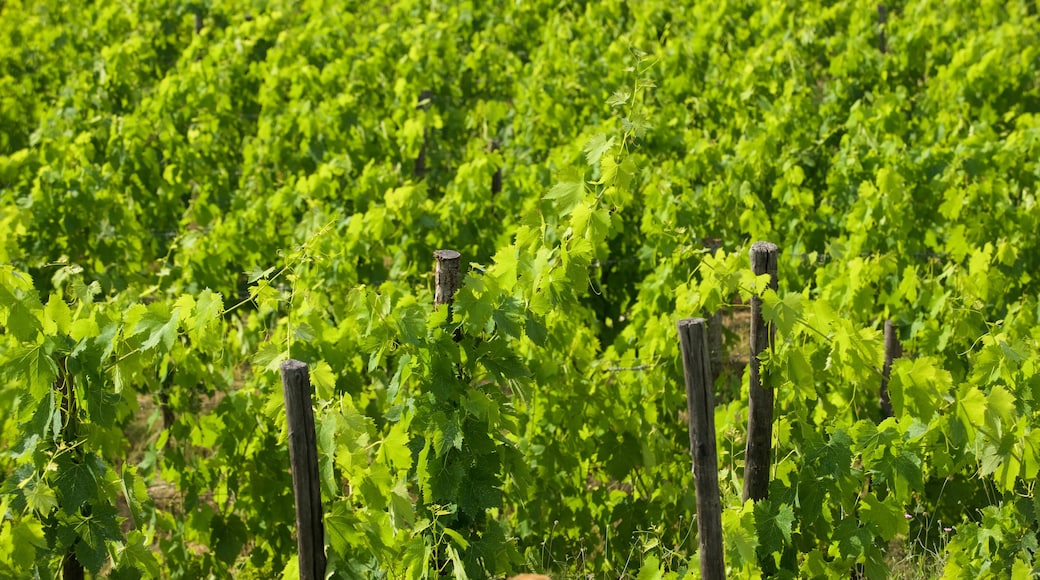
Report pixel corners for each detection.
[678,318,726,578]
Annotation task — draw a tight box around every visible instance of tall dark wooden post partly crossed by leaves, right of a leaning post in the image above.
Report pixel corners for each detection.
[744,241,777,501]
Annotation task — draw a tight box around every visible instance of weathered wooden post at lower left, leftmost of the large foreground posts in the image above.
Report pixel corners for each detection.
[281,359,326,580]
